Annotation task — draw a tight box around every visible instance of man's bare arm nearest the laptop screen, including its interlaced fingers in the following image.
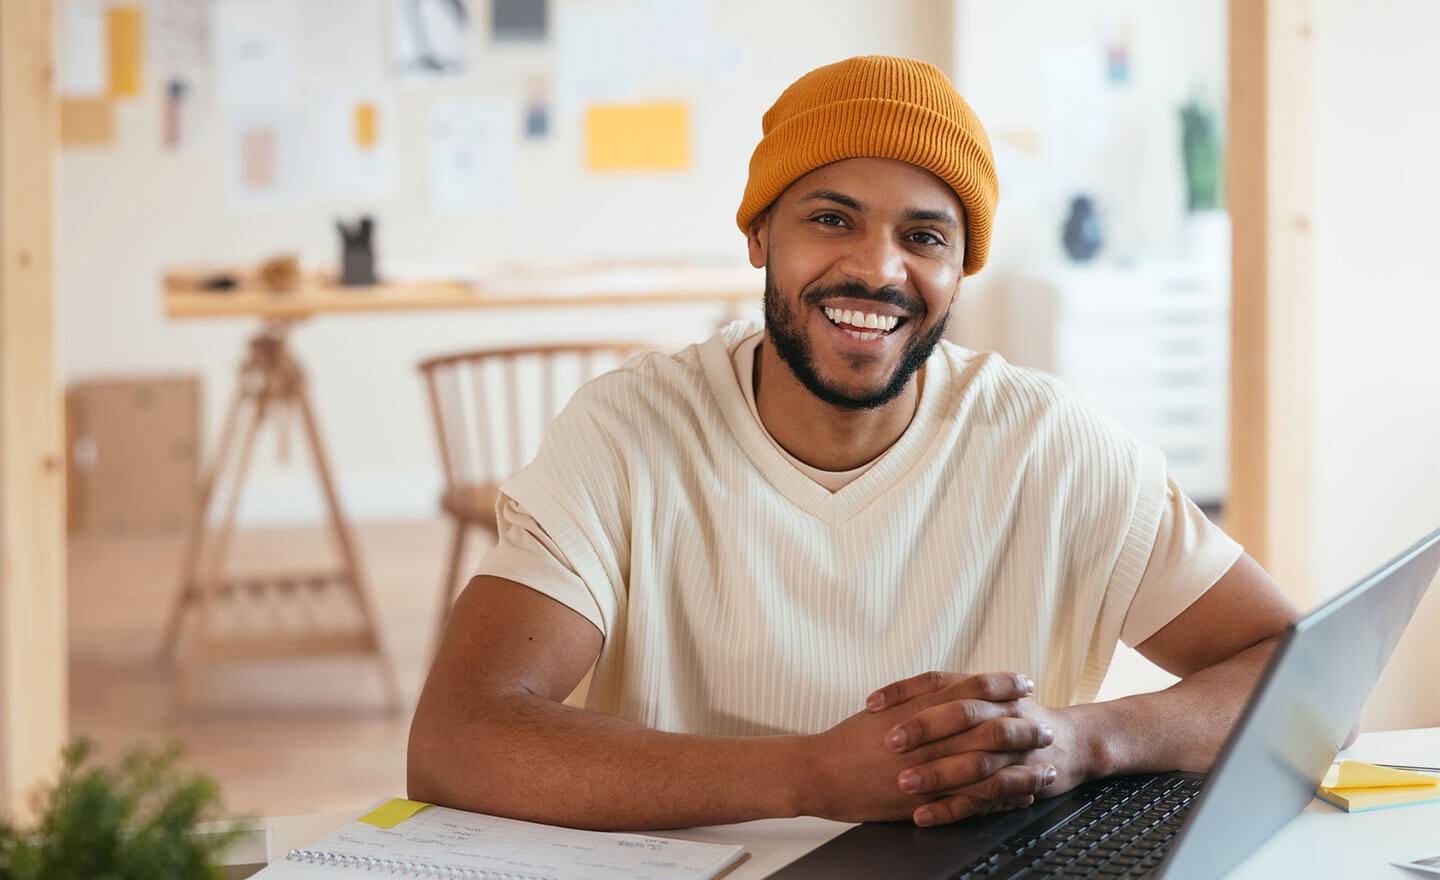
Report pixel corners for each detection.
[871,556,1299,824]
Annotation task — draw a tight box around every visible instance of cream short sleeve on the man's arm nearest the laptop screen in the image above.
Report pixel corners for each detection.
[1120,480,1241,647]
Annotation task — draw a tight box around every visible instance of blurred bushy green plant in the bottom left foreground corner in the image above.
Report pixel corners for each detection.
[0,740,236,880]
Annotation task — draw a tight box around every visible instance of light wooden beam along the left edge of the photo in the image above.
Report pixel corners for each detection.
[0,0,68,818]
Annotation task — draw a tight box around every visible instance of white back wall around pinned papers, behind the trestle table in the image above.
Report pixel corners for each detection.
[56,0,950,521]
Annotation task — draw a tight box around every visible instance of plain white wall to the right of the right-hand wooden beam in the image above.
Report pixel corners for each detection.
[1312,0,1440,729]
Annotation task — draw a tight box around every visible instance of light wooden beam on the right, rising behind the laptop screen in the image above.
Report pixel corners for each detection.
[1225,0,1315,606]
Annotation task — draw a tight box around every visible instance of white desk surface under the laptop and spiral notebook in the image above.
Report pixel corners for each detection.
[266,727,1440,880]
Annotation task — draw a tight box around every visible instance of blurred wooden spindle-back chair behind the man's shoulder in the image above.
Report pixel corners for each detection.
[420,341,654,645]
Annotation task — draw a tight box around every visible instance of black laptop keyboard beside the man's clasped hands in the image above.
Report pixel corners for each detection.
[950,776,1202,880]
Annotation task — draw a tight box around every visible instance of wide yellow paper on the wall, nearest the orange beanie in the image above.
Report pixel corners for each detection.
[585,102,690,171]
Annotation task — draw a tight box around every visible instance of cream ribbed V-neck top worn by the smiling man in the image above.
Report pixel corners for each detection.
[480,325,1240,733]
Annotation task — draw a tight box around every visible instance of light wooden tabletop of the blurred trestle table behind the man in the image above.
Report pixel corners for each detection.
[164,264,765,321]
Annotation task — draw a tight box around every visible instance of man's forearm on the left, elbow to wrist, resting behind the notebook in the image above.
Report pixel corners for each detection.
[409,691,806,830]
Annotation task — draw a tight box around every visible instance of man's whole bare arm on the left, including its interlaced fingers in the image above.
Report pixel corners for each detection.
[409,578,1045,830]
